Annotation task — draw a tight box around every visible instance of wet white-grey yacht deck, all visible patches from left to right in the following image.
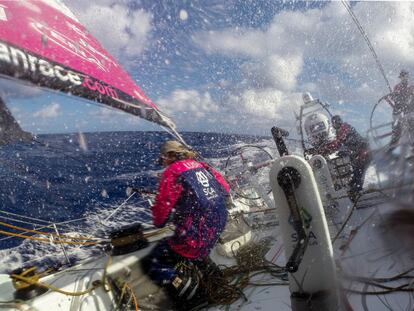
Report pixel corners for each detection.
[1,194,414,310]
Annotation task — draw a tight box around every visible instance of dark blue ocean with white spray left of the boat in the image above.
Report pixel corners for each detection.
[0,132,264,271]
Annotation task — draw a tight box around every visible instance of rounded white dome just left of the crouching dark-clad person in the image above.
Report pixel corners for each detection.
[304,113,335,146]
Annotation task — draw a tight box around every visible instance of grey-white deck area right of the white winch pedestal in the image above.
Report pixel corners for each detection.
[333,195,414,310]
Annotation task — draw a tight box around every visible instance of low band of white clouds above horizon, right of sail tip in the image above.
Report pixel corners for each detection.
[157,88,301,134]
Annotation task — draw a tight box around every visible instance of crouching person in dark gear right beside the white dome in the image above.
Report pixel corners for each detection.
[330,115,371,200]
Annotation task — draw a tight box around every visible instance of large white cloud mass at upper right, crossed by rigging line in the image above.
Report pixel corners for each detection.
[189,2,414,134]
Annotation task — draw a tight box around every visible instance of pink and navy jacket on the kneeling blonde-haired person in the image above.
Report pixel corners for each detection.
[152,159,230,259]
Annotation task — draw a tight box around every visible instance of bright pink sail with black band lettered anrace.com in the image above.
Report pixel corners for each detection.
[0,0,175,130]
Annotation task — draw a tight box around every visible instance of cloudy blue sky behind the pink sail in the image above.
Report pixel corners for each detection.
[0,0,414,135]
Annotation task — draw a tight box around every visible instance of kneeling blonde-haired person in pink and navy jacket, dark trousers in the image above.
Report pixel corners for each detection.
[143,141,230,310]
